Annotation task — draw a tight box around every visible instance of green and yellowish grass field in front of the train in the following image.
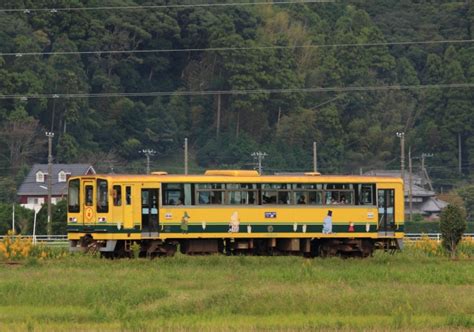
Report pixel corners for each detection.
[0,250,474,331]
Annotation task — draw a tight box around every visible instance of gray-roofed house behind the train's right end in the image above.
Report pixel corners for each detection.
[365,170,448,219]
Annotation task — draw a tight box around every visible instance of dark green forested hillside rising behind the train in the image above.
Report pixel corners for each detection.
[0,0,474,199]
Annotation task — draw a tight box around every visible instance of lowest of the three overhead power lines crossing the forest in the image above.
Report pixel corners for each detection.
[0,83,474,100]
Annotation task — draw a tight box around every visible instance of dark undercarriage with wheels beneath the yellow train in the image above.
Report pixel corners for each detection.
[70,235,401,258]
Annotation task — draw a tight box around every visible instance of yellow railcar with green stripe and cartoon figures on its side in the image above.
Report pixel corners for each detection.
[67,171,404,257]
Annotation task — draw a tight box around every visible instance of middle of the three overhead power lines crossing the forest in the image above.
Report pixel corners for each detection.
[0,39,474,57]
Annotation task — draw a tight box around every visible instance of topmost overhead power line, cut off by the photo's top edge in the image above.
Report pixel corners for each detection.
[0,0,335,14]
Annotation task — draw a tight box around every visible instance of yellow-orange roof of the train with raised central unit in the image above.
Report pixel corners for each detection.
[71,171,403,183]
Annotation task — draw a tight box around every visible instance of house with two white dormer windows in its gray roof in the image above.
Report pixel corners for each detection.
[17,164,95,210]
